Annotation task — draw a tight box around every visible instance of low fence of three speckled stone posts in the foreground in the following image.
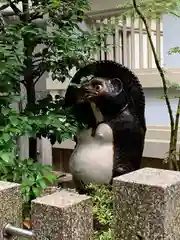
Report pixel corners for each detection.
[0,168,180,240]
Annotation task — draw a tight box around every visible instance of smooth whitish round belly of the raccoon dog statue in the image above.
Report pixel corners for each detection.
[69,124,114,184]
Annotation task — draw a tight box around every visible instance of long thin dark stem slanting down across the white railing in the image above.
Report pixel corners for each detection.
[133,0,174,130]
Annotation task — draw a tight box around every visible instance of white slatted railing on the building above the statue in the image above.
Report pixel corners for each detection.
[87,15,163,69]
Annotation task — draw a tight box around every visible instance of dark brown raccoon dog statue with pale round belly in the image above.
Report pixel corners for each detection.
[65,61,146,193]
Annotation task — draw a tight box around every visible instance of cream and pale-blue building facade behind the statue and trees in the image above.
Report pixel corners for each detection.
[0,0,180,168]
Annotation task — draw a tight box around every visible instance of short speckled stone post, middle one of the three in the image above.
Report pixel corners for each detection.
[32,190,93,240]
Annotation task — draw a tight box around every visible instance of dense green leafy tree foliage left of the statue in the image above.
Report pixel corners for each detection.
[0,0,108,201]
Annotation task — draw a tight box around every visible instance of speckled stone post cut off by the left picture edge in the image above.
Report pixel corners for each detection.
[0,181,22,239]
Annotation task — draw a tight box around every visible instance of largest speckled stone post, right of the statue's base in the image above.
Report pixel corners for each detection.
[113,168,180,240]
